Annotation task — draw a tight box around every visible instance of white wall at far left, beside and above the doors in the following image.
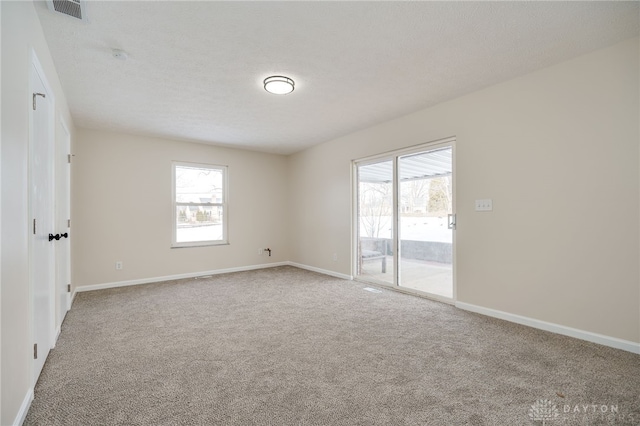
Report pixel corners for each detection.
[0,1,74,425]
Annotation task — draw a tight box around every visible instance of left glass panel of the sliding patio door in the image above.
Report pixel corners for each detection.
[357,160,395,284]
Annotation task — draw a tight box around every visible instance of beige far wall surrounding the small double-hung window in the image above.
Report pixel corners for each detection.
[71,129,289,288]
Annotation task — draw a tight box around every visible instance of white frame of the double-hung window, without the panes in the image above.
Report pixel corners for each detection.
[171,161,229,248]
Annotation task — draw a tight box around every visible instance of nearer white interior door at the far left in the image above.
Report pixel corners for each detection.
[29,57,55,384]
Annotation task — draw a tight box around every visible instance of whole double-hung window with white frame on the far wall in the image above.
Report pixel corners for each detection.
[171,162,228,247]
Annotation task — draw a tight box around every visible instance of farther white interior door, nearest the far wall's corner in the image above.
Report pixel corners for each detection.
[55,121,71,333]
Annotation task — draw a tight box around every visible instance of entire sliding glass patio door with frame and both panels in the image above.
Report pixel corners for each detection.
[355,141,455,300]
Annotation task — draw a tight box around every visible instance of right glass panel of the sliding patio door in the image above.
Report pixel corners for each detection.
[397,147,453,298]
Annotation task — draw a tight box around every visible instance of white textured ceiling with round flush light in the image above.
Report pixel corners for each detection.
[36,1,639,154]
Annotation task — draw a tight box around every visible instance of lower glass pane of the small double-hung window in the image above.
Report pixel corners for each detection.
[176,205,224,243]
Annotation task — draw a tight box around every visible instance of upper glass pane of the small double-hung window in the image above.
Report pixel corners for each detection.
[175,166,225,204]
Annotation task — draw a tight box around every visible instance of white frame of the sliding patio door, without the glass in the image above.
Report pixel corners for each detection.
[351,137,457,304]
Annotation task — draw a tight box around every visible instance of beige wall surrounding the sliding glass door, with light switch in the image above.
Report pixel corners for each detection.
[289,39,640,342]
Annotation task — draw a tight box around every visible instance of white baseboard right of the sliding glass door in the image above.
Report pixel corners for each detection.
[455,302,640,354]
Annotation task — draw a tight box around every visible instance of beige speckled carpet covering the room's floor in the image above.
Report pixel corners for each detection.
[25,267,640,426]
